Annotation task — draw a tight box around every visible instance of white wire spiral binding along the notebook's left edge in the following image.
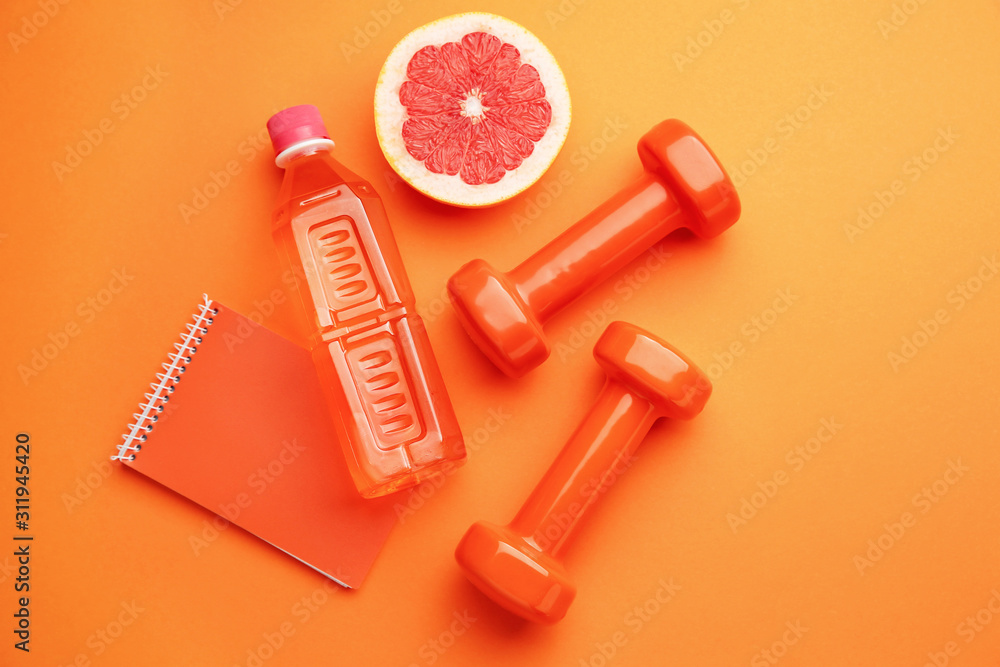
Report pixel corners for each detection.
[111,294,219,461]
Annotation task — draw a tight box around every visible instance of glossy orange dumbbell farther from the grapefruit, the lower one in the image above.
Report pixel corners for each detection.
[455,322,712,623]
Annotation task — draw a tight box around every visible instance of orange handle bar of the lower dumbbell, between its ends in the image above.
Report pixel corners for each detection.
[510,378,661,556]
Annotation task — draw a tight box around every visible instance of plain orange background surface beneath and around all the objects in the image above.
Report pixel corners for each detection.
[0,0,1000,666]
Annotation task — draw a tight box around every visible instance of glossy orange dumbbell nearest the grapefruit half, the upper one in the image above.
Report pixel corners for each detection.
[448,120,740,377]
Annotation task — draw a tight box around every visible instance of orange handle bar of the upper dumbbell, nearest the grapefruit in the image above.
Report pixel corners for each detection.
[508,171,686,322]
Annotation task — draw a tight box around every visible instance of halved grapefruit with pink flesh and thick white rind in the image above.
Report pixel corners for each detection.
[375,13,570,207]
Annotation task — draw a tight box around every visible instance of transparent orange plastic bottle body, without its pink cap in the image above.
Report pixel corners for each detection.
[273,134,466,497]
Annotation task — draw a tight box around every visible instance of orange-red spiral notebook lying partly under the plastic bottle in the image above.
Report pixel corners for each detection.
[112,296,396,588]
